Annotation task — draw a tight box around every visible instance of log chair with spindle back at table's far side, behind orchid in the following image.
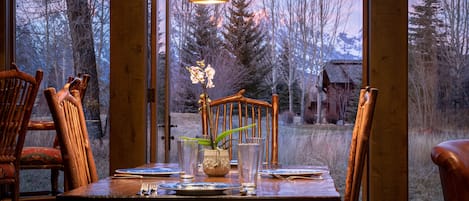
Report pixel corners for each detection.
[199,89,279,166]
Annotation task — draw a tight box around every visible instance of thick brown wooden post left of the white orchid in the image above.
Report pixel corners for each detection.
[109,0,148,174]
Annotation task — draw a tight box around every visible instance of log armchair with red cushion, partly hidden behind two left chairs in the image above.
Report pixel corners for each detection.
[20,74,90,196]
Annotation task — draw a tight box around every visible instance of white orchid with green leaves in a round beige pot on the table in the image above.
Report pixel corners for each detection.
[185,60,255,176]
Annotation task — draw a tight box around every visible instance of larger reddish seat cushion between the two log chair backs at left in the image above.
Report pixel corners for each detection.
[20,147,62,165]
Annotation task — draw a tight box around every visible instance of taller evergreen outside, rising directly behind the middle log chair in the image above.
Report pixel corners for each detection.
[223,0,270,98]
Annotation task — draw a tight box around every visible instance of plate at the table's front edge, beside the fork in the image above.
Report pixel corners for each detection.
[158,182,239,195]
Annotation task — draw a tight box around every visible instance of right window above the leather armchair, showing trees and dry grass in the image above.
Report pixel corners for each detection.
[409,0,469,200]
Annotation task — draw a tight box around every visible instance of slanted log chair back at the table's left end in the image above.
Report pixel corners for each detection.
[44,83,98,190]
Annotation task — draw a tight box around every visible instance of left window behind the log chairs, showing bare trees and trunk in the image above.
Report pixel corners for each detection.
[16,0,109,191]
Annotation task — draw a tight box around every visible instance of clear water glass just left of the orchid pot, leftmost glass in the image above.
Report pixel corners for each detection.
[177,138,199,179]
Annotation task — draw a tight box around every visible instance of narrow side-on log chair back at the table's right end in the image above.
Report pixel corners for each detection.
[344,87,378,201]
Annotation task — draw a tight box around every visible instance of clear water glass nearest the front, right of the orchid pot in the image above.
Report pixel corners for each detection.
[238,143,260,195]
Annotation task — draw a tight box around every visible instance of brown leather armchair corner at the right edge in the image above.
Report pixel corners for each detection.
[431,139,469,201]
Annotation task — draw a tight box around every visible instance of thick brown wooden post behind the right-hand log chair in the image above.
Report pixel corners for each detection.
[369,0,408,201]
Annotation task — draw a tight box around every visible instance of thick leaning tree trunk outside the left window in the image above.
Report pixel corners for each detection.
[67,0,103,138]
